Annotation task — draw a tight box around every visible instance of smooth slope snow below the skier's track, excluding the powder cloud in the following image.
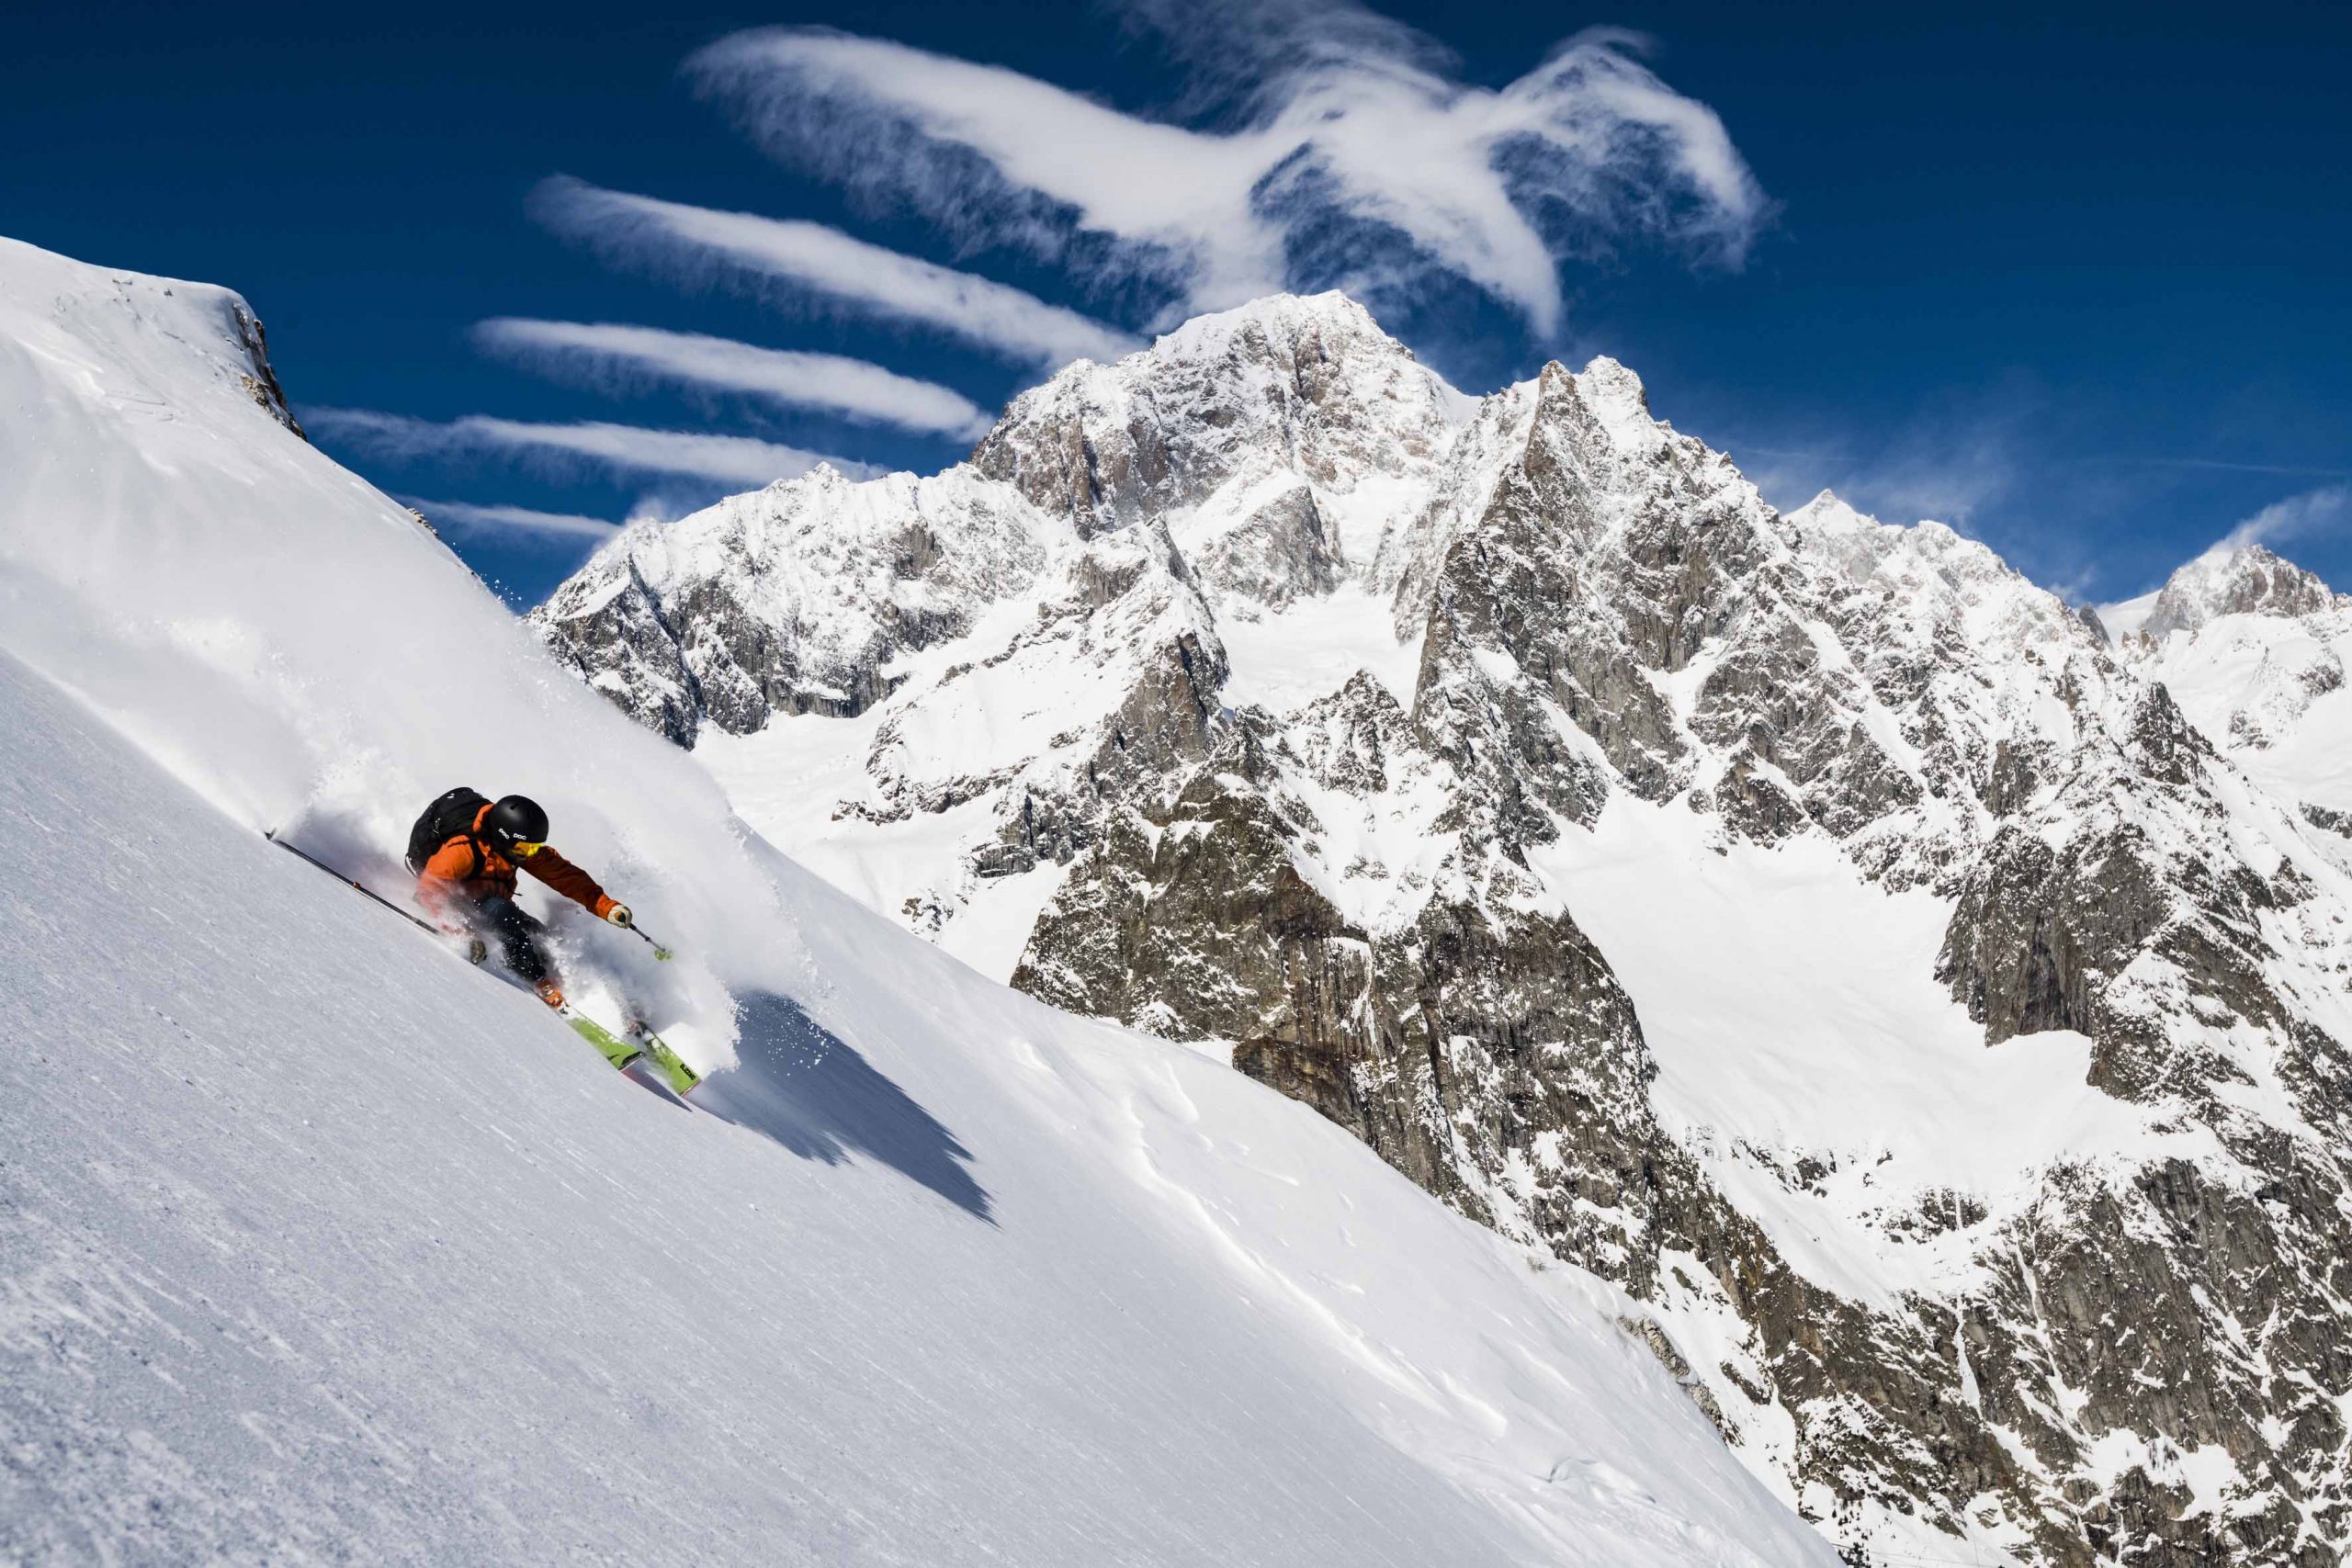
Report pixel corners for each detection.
[0,639,1820,1563]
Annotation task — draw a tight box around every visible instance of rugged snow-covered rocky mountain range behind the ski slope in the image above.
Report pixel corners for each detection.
[534,294,2352,1568]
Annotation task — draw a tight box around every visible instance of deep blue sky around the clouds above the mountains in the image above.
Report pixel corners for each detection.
[0,0,2352,602]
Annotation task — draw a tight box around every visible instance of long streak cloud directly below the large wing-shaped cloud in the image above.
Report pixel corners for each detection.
[529,176,1138,369]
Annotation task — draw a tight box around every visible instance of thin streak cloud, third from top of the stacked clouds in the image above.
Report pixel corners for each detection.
[473,317,988,437]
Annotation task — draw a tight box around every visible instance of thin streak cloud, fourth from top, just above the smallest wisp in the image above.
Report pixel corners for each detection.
[303,409,873,487]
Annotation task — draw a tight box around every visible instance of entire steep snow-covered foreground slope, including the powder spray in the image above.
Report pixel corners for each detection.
[0,243,1826,1568]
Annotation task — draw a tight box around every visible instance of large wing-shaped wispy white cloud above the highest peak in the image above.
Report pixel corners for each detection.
[687,0,1769,339]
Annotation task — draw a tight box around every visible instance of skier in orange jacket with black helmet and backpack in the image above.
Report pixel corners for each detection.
[409,785,633,1009]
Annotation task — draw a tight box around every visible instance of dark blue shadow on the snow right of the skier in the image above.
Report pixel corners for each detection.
[694,992,995,1224]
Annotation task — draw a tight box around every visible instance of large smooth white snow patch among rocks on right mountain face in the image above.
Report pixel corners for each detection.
[1532,795,2209,1307]
